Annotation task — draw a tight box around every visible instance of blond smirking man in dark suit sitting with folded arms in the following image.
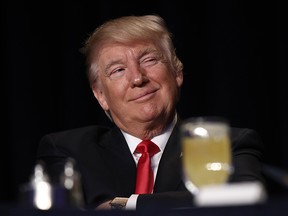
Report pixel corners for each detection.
[37,15,262,209]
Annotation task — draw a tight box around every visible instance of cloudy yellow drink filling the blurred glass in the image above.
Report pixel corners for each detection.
[182,136,231,187]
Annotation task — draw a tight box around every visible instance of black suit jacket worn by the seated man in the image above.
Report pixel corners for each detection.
[37,123,262,209]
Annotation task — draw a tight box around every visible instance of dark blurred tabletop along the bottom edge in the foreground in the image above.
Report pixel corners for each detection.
[0,194,288,216]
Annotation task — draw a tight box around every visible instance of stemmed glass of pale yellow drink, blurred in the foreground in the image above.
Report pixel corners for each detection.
[180,117,232,194]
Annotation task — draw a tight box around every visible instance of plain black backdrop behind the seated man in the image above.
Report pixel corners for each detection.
[0,0,288,202]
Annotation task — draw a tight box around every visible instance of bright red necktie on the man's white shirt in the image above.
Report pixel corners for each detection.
[135,140,160,194]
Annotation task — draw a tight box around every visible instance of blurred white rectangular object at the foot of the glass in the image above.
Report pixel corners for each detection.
[194,182,267,206]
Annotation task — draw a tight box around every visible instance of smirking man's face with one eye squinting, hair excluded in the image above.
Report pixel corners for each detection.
[93,42,183,132]
